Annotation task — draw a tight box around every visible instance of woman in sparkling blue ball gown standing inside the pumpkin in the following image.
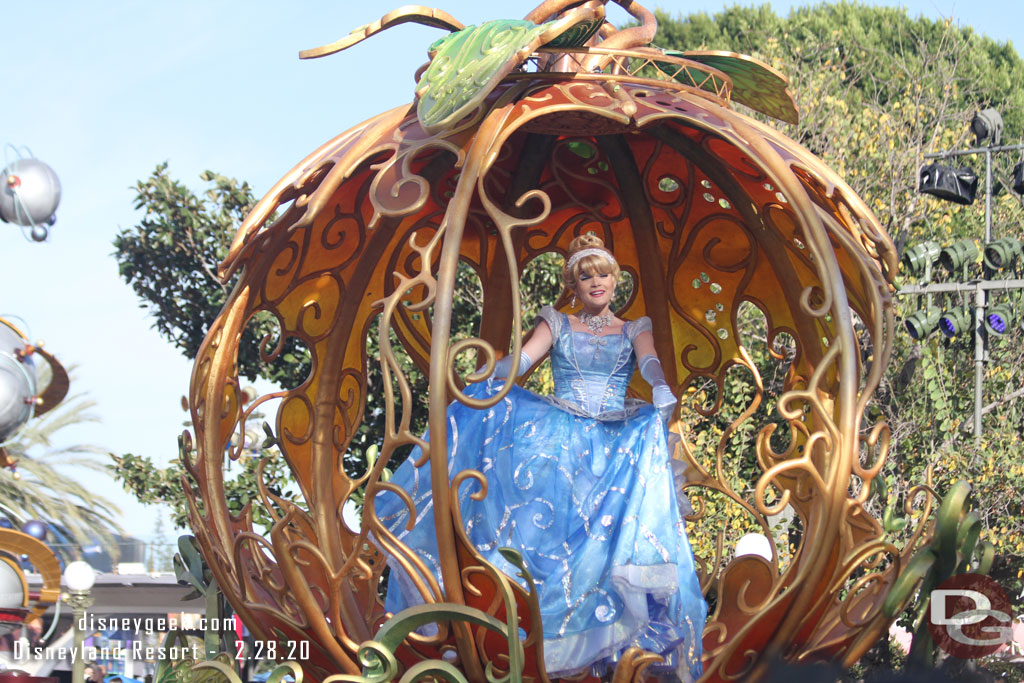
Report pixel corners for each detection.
[376,233,708,681]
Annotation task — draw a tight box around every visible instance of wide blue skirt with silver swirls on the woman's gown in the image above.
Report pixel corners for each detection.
[376,381,708,681]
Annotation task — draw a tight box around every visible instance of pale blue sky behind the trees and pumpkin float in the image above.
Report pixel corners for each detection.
[0,0,1024,538]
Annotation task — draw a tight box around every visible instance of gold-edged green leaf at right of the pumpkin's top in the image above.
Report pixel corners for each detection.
[665,50,800,124]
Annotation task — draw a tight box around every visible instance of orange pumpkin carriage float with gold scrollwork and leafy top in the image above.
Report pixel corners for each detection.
[178,0,942,681]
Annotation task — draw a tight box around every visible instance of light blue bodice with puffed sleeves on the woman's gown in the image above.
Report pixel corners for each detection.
[540,306,650,419]
